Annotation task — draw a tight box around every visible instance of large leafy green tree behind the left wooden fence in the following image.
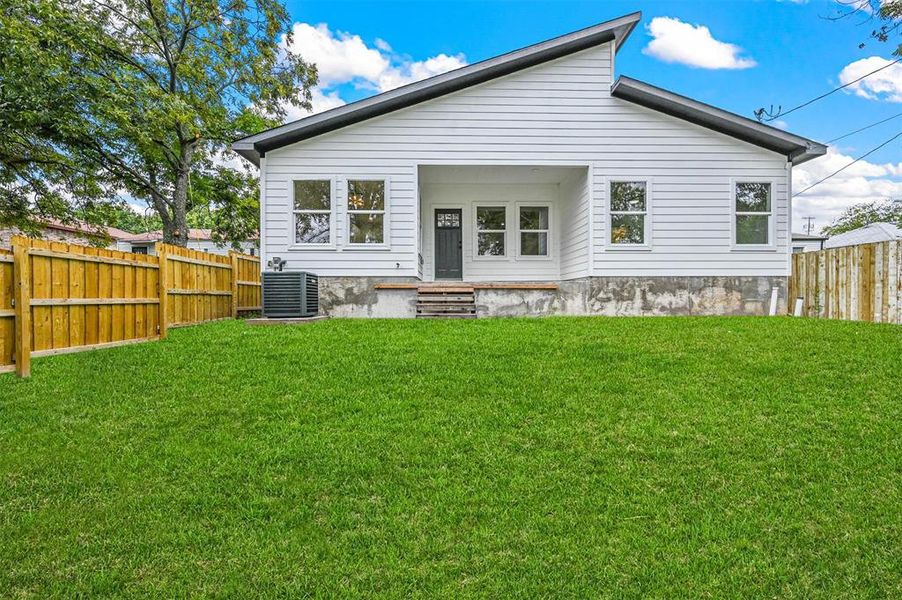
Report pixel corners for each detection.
[0,0,316,245]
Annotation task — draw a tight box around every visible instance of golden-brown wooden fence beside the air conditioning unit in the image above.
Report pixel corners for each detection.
[0,237,261,377]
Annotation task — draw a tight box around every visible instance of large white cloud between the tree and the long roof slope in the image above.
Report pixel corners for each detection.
[286,23,467,120]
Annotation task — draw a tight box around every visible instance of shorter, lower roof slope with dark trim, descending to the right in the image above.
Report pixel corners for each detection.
[611,76,827,165]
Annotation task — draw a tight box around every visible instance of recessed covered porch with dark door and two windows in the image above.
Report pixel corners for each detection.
[414,165,590,289]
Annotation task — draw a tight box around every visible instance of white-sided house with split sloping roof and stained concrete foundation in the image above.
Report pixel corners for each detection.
[233,13,826,316]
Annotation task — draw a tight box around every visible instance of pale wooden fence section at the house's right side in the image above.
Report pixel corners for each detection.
[788,241,902,324]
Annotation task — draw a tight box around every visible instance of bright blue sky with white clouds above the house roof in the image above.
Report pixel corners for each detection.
[278,0,902,230]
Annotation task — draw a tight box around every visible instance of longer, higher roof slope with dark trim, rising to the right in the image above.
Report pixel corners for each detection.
[232,12,642,165]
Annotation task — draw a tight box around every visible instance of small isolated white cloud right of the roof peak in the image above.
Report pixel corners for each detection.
[642,17,757,69]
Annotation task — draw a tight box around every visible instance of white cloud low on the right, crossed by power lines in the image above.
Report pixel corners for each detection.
[792,146,902,232]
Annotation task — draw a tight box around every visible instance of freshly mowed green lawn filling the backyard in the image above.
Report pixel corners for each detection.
[0,318,902,598]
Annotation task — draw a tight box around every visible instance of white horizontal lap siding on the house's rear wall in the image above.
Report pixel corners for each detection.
[262,44,789,279]
